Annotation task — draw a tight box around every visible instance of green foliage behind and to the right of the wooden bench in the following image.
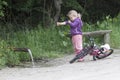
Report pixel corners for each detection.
[83,14,120,48]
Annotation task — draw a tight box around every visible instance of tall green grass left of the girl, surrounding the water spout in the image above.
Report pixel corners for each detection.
[0,26,72,66]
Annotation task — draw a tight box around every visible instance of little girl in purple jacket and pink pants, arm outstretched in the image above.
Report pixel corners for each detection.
[57,10,83,62]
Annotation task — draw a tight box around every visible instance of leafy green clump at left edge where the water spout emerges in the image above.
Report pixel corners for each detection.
[0,40,19,67]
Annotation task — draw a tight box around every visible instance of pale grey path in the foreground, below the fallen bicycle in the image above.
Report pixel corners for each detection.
[0,50,120,80]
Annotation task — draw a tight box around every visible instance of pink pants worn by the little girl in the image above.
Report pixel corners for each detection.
[72,35,82,54]
